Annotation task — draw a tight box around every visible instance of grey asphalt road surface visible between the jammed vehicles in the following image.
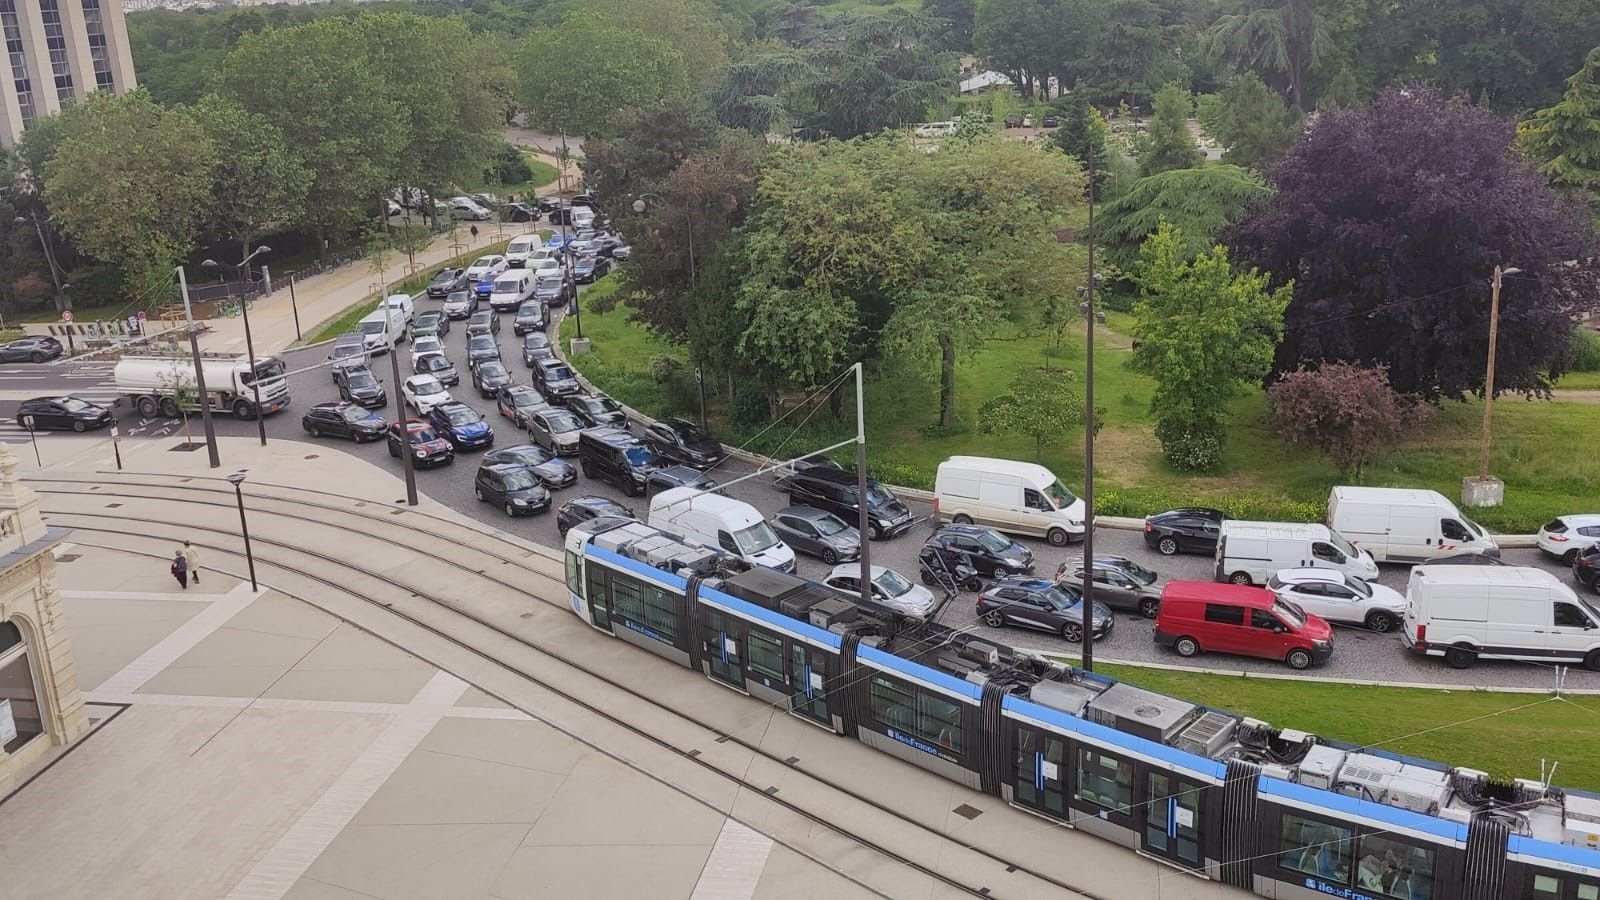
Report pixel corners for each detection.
[0,283,1600,689]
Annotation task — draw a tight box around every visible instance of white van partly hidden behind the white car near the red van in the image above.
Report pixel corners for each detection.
[1216,519,1378,585]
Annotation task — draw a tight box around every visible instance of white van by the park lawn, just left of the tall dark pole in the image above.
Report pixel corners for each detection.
[933,456,1083,546]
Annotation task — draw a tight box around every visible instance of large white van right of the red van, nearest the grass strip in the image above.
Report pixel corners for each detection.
[1400,565,1600,669]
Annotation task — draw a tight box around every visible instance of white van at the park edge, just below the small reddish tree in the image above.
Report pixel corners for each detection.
[1328,485,1499,562]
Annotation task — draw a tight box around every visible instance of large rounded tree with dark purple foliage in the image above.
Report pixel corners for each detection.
[1222,86,1600,400]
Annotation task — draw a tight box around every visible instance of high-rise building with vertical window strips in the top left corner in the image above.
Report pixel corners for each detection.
[0,0,134,146]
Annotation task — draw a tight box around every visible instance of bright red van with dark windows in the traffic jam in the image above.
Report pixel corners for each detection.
[1155,581,1333,669]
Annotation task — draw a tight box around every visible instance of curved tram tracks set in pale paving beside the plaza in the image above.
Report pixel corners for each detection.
[29,476,1113,897]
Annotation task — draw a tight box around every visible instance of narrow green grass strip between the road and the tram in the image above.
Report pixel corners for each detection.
[1075,663,1600,791]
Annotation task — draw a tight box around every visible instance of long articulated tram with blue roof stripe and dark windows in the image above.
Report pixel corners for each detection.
[565,519,1600,900]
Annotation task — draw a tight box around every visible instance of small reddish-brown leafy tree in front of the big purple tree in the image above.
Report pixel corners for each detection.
[1267,362,1427,480]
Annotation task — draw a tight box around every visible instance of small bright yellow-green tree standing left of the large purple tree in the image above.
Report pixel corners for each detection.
[1133,223,1293,471]
